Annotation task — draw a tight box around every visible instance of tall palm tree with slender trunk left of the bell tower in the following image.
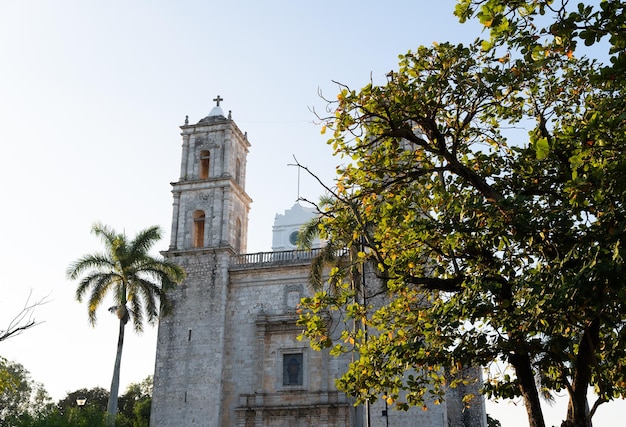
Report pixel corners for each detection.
[67,223,185,426]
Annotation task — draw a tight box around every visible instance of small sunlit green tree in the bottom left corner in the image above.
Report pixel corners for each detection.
[0,357,50,426]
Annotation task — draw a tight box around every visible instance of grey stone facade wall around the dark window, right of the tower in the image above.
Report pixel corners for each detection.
[221,262,354,426]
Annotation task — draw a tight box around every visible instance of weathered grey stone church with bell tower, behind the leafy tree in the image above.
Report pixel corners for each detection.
[150,96,486,427]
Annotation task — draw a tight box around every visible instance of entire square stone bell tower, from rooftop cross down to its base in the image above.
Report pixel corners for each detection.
[150,96,251,427]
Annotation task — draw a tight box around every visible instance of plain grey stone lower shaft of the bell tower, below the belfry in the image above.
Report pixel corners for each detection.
[151,251,230,427]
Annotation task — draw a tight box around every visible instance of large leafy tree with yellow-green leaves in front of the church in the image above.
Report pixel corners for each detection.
[301,0,626,427]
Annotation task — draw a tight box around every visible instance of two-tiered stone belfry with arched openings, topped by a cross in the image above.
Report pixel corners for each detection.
[170,96,251,253]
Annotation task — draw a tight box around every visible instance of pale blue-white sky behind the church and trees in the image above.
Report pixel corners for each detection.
[0,0,626,427]
